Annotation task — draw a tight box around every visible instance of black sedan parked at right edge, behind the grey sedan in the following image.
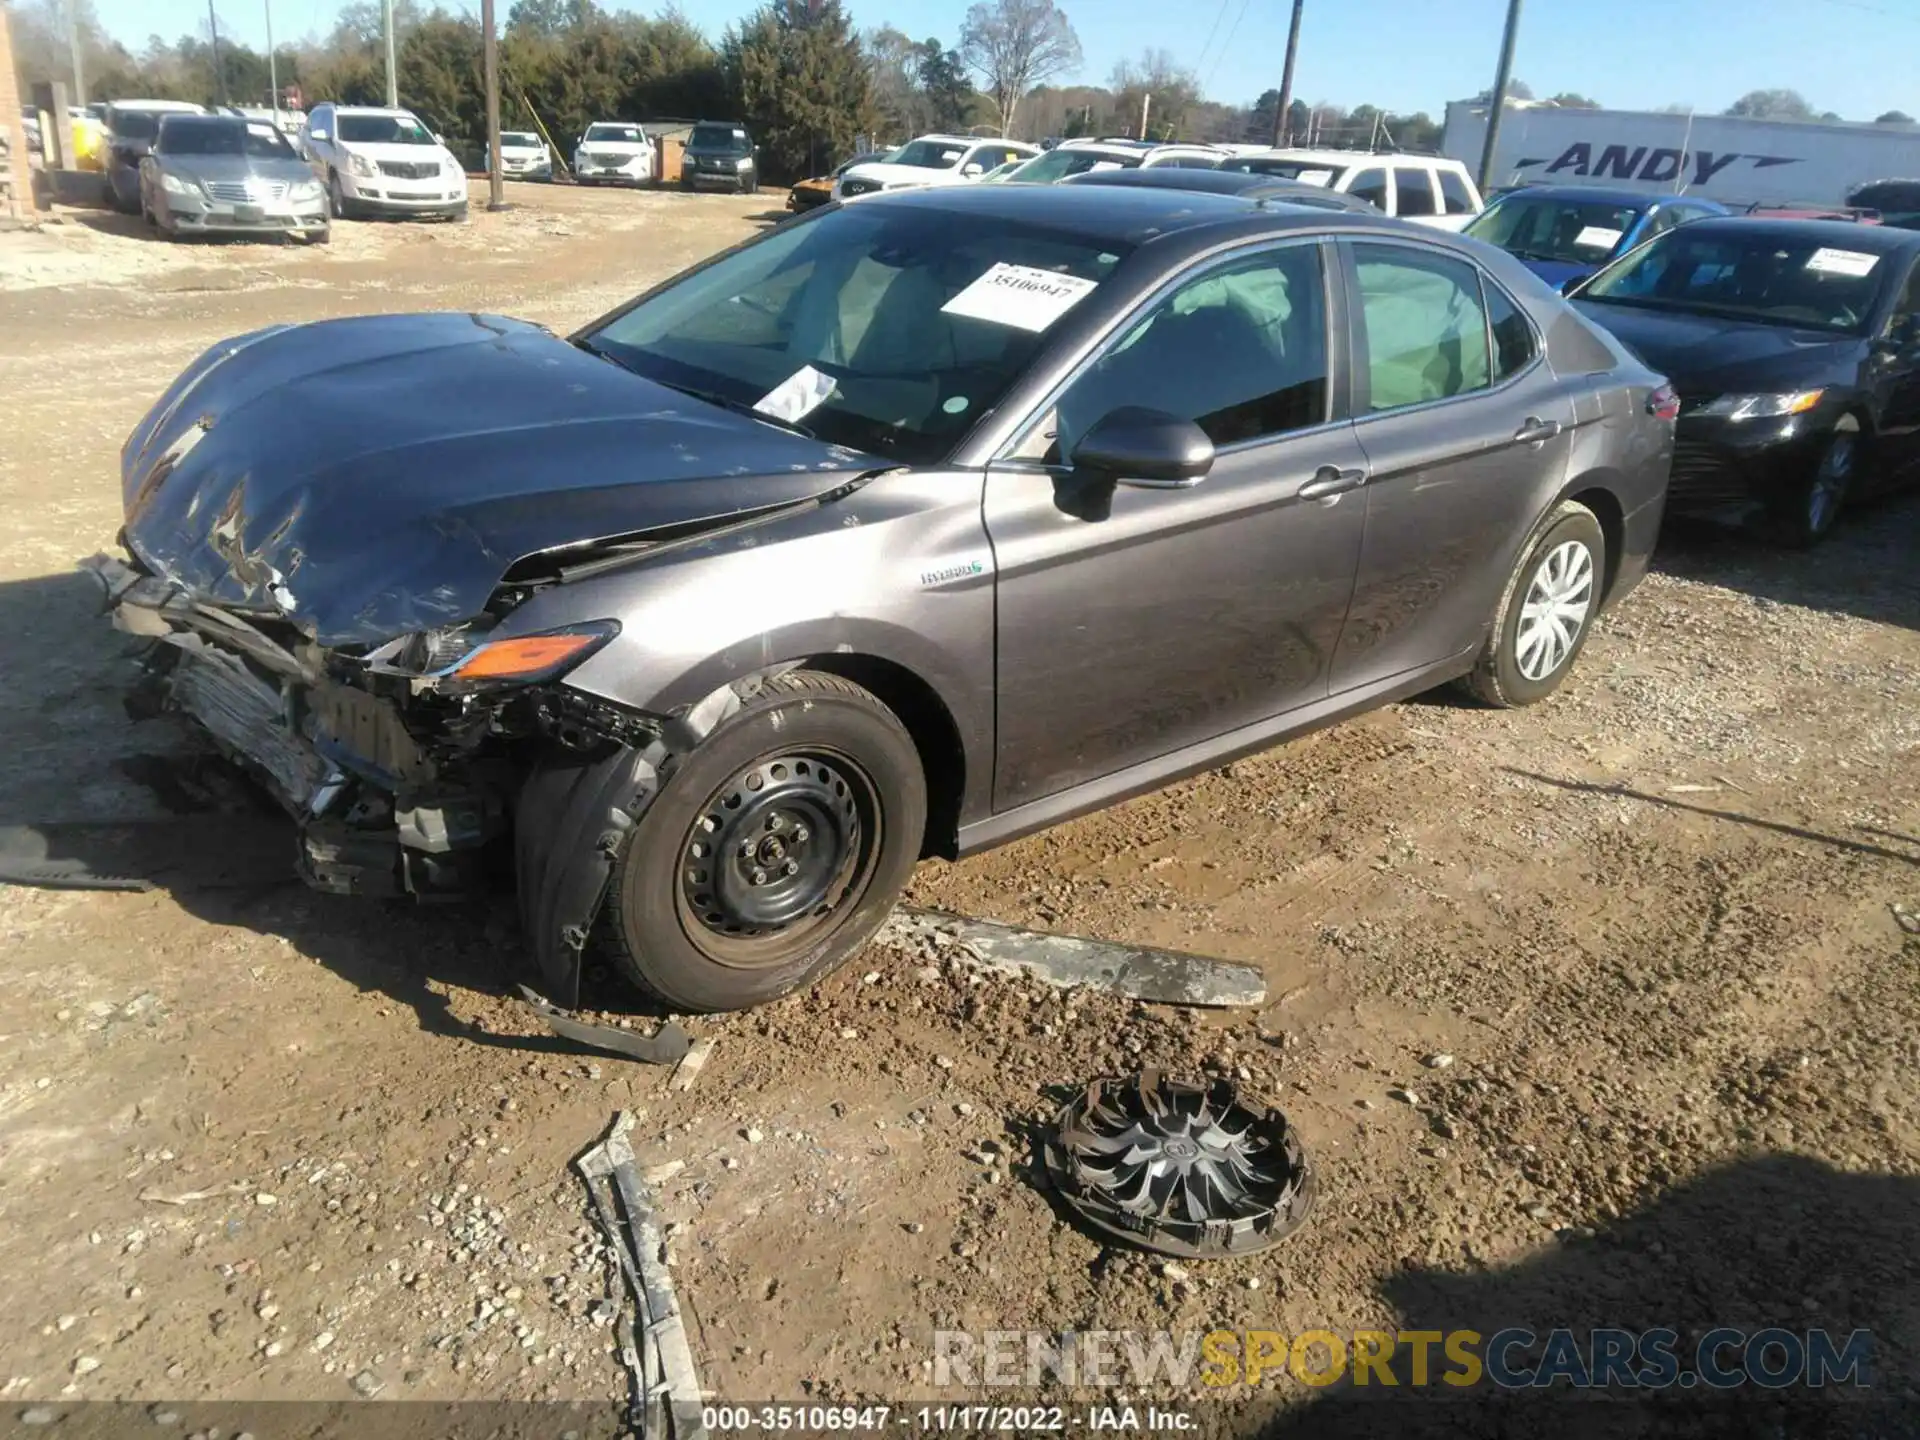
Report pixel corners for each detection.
[1574,219,1920,545]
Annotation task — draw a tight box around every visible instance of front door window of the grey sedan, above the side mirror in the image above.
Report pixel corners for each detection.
[1021,244,1329,465]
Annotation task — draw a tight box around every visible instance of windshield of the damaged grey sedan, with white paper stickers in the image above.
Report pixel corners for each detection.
[584,205,1129,465]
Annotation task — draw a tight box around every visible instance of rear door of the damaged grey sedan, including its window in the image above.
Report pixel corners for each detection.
[1332,240,1578,693]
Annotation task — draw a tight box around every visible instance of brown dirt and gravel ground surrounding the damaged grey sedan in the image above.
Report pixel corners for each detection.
[0,177,1920,1434]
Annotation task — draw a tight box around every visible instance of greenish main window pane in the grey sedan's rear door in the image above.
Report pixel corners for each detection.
[1354,244,1492,411]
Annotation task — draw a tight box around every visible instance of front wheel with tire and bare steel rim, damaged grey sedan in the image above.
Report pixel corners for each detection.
[607,670,927,1012]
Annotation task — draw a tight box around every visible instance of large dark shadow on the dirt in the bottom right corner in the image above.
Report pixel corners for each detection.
[1260,1154,1920,1440]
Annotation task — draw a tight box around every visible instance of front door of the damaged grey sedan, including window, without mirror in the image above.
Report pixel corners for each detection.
[985,240,1365,810]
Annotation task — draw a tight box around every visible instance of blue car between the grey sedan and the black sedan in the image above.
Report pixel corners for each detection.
[1465,184,1730,290]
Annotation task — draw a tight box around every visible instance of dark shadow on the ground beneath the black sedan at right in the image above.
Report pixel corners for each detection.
[1653,493,1920,630]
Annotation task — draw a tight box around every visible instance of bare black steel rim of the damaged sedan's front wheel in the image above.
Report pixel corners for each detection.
[676,753,879,970]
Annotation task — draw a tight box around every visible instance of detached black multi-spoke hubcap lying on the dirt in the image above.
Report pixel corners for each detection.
[1043,1069,1315,1260]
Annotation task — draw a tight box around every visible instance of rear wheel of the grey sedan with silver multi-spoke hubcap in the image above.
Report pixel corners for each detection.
[1465,501,1607,710]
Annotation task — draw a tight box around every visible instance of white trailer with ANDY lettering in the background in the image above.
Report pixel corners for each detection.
[1440,100,1920,207]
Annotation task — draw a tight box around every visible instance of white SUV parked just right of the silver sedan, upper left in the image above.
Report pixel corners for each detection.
[300,106,467,221]
